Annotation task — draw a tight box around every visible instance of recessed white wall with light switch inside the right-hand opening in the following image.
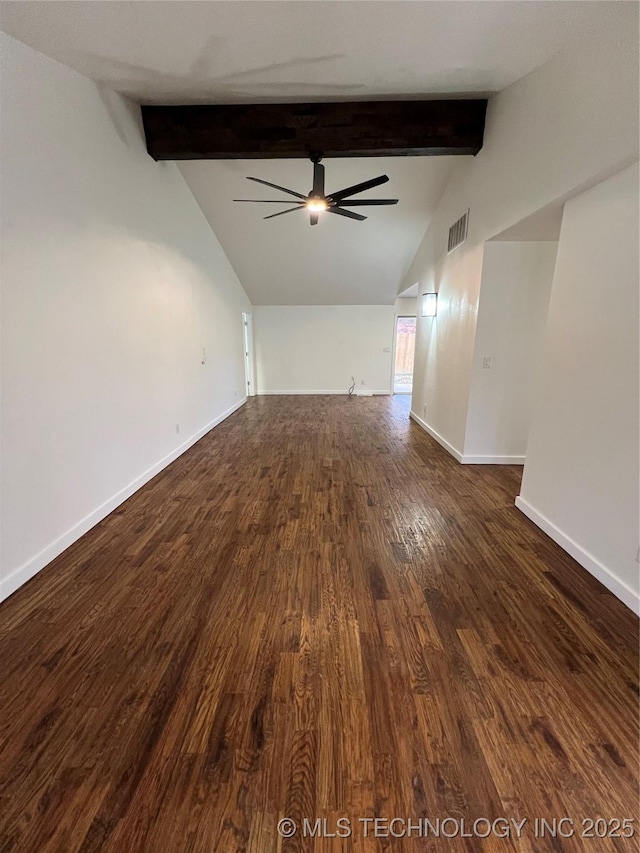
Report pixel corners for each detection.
[464,241,558,464]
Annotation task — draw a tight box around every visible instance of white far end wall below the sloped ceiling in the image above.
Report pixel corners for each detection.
[253,305,395,394]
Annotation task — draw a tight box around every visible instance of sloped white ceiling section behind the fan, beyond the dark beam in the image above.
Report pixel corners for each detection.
[179,157,458,305]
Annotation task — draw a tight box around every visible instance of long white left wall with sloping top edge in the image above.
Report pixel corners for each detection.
[0,36,249,596]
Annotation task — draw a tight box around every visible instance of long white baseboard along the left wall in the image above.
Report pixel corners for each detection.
[0,397,247,601]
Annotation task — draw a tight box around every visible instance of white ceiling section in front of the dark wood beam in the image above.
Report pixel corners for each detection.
[1,0,620,103]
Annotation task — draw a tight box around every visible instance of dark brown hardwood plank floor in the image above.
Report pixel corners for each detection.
[0,397,638,853]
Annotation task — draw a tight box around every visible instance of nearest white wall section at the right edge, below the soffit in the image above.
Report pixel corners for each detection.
[517,165,640,610]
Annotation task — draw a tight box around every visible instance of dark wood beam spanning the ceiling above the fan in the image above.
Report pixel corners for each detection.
[142,98,487,160]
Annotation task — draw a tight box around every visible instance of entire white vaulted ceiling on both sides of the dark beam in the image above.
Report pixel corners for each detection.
[1,0,611,304]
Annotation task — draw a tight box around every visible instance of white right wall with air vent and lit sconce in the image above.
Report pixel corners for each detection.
[408,11,638,454]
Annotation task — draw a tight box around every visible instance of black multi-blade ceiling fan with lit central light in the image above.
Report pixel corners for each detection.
[233,154,398,225]
